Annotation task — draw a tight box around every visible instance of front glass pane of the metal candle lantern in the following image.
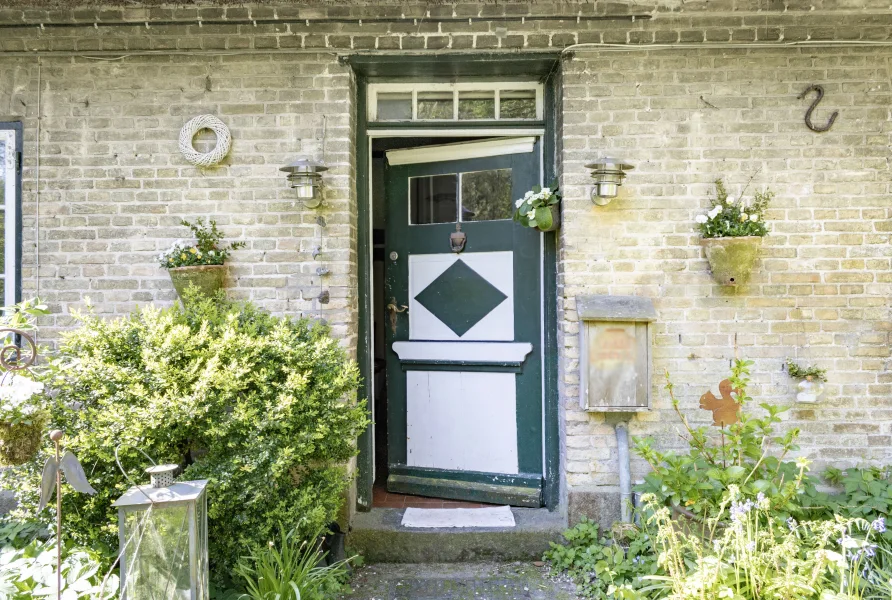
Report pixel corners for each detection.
[124,504,193,600]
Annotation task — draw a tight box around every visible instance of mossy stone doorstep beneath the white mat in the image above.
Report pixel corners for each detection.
[346,508,567,563]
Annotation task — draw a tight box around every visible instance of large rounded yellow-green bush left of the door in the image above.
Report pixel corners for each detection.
[0,295,366,573]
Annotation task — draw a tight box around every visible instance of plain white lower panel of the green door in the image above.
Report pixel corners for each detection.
[406,371,518,473]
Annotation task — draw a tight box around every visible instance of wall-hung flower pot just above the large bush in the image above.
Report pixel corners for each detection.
[158,218,245,299]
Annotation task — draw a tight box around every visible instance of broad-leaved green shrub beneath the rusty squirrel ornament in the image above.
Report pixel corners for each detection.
[635,360,814,517]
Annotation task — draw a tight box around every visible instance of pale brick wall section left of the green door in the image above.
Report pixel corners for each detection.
[0,54,356,338]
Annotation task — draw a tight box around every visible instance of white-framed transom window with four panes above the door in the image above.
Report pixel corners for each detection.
[368,81,543,122]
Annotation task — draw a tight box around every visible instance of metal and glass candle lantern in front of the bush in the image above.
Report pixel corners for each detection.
[114,465,208,600]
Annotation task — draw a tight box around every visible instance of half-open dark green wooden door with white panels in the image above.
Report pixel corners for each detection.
[383,143,543,506]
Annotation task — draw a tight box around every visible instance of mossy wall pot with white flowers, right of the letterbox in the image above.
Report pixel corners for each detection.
[696,179,774,285]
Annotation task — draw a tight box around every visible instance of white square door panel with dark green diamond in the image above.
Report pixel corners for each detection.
[409,252,514,341]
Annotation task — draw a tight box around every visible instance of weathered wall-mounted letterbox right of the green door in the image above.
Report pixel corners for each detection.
[576,296,657,412]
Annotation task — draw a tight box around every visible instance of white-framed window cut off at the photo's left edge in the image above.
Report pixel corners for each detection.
[0,122,22,306]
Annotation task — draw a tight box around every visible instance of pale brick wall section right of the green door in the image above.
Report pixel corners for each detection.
[560,48,892,516]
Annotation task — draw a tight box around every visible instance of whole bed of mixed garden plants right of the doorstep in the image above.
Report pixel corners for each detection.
[546,360,892,600]
